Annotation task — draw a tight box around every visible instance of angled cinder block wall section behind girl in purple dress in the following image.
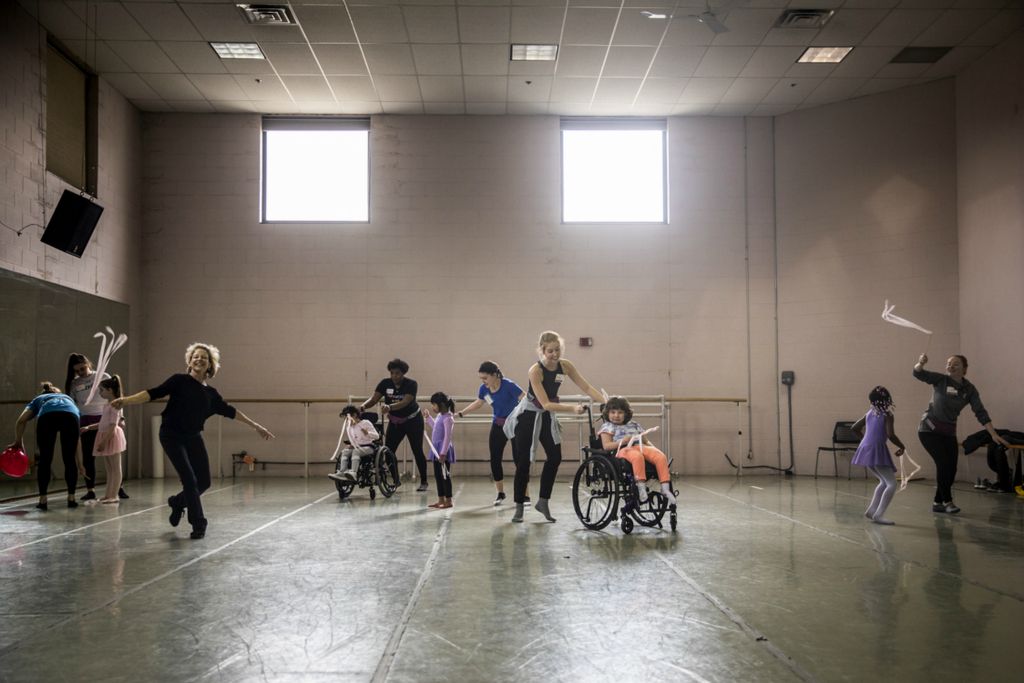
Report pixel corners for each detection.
[775,80,973,477]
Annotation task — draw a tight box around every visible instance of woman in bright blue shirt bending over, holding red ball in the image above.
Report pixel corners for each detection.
[5,382,82,510]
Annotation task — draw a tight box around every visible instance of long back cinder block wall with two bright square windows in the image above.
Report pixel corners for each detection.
[142,115,777,473]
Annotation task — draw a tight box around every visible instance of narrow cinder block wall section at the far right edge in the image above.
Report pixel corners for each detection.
[954,30,1024,431]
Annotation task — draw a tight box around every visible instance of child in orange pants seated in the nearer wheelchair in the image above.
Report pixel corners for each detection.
[597,396,676,507]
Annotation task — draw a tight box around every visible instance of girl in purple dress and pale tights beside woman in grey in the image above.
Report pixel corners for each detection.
[852,386,905,524]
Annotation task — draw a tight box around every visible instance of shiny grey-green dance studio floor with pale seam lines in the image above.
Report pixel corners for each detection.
[0,472,1024,683]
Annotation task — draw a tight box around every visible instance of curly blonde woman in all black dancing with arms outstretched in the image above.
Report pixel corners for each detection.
[111,343,273,539]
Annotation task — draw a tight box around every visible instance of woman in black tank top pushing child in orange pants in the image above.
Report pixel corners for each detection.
[512,331,605,522]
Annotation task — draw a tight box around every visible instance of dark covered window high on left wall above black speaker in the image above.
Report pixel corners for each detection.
[46,46,89,189]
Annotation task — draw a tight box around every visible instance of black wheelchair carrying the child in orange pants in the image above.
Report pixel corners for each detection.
[572,405,679,533]
